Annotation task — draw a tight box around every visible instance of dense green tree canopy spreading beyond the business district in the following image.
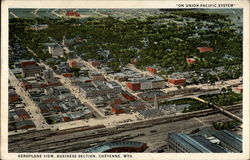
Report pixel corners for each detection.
[10,11,242,79]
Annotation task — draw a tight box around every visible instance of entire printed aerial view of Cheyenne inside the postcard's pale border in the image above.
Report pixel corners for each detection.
[8,8,243,153]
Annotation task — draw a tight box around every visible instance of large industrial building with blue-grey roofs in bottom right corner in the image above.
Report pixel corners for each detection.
[168,129,242,153]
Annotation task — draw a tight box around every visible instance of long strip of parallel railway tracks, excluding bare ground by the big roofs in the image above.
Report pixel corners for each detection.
[9,105,242,153]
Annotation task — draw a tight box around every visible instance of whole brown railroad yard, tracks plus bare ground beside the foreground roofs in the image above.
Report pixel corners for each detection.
[9,106,242,153]
